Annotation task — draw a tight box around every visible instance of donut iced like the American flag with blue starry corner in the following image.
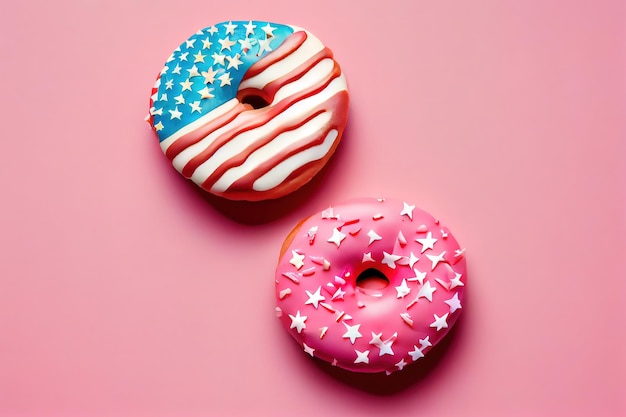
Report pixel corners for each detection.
[146,21,349,201]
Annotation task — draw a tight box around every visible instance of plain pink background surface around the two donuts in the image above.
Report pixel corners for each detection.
[0,0,626,417]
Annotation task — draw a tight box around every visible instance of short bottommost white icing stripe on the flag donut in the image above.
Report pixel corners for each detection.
[252,129,338,191]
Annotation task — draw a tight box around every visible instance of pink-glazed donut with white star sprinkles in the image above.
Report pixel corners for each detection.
[275,198,467,374]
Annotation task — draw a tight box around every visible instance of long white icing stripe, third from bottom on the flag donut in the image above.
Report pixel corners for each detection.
[191,77,345,184]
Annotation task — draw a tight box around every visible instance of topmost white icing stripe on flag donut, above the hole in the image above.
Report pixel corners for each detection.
[234,32,324,90]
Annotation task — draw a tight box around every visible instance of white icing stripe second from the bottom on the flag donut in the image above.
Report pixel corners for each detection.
[211,112,332,192]
